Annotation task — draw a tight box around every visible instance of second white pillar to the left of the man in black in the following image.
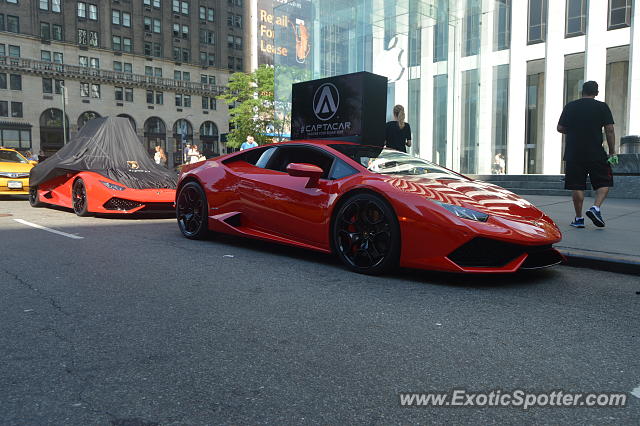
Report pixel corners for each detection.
[507,0,528,174]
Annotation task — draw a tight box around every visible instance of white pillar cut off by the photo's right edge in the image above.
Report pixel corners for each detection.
[617,1,640,137]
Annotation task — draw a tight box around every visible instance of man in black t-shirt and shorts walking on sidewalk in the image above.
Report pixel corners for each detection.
[557,81,618,228]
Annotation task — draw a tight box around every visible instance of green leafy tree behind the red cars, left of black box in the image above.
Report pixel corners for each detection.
[220,65,275,148]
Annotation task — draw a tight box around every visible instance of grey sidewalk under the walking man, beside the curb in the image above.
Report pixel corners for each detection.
[522,195,640,275]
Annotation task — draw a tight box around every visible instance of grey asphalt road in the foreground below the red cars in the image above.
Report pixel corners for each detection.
[0,198,640,425]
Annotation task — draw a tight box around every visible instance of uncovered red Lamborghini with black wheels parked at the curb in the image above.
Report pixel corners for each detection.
[176,141,562,274]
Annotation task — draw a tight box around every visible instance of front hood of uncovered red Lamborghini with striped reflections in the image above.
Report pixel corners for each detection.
[389,174,543,220]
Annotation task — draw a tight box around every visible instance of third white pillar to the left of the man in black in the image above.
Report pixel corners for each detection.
[476,0,495,175]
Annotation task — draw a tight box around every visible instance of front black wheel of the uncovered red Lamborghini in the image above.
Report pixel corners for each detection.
[332,193,400,275]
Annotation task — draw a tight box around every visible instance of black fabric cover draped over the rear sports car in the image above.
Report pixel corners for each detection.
[29,117,177,189]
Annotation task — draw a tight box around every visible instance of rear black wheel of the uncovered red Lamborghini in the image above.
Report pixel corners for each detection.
[176,182,209,240]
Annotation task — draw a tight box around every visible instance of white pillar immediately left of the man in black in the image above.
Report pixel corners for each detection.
[538,1,564,174]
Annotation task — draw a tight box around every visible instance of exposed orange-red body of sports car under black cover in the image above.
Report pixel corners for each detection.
[29,172,176,216]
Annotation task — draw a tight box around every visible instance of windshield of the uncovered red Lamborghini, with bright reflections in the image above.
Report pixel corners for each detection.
[330,144,460,179]
